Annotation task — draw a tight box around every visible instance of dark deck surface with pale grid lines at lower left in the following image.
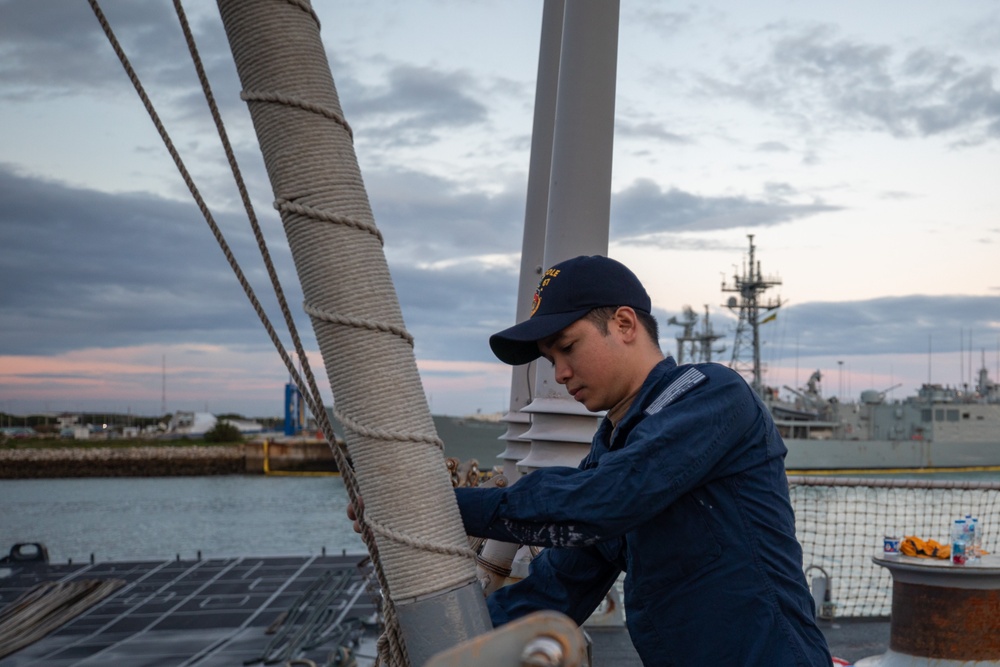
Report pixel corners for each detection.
[0,556,377,667]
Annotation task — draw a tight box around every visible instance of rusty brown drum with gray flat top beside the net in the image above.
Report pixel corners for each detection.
[856,554,1000,667]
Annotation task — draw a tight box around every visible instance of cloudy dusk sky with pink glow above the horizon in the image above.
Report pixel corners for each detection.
[0,0,1000,416]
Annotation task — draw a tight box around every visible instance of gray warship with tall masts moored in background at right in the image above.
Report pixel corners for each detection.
[668,235,1000,474]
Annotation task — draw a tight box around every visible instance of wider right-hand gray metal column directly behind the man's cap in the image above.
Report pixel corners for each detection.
[518,0,619,472]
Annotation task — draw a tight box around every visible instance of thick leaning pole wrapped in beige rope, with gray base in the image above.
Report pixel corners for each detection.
[218,0,492,665]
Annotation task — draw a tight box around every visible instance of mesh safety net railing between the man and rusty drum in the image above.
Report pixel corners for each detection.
[788,476,1000,618]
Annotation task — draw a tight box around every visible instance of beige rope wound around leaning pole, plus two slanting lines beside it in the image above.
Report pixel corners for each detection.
[89,0,488,666]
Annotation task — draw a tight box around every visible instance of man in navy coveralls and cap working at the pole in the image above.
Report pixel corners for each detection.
[455,256,832,667]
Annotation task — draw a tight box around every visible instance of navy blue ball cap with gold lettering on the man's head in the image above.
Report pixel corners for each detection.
[490,255,651,366]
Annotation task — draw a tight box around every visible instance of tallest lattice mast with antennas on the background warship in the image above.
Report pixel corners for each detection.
[722,234,781,397]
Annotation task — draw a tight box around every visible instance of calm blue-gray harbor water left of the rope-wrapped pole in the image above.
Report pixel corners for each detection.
[0,476,365,562]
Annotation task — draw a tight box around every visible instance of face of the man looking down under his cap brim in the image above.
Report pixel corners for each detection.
[538,318,630,412]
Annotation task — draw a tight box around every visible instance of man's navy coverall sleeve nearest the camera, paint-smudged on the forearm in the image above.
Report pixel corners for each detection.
[455,369,764,546]
